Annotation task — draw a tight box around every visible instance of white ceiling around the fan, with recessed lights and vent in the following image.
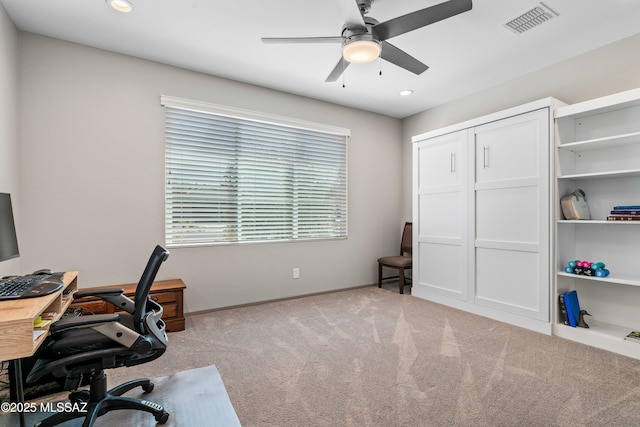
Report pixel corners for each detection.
[0,0,640,118]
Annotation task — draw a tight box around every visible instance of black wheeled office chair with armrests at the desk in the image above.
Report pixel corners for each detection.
[27,246,169,427]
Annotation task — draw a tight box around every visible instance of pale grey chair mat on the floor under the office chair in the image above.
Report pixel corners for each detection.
[0,366,240,427]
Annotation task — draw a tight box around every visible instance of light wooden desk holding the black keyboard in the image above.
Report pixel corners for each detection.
[0,271,78,360]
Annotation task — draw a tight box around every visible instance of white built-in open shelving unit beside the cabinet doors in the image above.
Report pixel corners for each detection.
[554,89,640,359]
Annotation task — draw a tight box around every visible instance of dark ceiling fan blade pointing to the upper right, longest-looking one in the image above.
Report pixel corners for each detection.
[372,0,472,40]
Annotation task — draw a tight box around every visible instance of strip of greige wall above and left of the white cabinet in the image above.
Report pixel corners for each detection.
[402,34,640,218]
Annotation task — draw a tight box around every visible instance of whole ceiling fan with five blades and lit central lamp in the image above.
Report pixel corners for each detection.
[262,0,472,82]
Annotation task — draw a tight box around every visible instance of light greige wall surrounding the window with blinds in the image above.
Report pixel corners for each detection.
[19,32,402,312]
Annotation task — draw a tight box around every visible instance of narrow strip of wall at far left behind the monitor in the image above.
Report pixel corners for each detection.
[0,5,22,277]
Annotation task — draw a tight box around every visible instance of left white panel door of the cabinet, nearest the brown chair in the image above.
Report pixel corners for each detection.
[412,130,469,300]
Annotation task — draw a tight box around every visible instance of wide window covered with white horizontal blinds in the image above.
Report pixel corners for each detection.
[161,96,349,247]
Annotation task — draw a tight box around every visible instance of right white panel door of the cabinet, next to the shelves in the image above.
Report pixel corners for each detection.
[474,109,549,321]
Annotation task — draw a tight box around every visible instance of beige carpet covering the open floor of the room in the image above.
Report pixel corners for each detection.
[162,284,640,427]
